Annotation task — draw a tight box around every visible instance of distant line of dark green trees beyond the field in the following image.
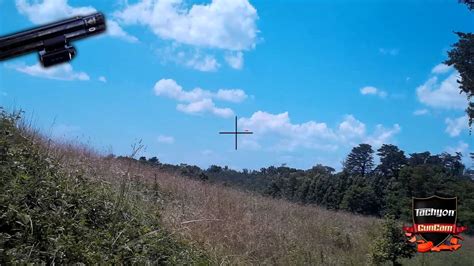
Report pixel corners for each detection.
[119,144,474,234]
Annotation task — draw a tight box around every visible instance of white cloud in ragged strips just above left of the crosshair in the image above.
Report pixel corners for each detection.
[154,79,247,117]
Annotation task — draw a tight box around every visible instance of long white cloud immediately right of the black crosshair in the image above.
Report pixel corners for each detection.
[239,111,401,151]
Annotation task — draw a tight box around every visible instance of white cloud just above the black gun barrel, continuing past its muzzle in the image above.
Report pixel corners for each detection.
[16,0,138,42]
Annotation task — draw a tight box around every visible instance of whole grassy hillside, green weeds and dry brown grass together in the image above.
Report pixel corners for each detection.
[0,109,474,265]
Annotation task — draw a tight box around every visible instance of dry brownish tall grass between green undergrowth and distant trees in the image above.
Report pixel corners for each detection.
[27,129,474,265]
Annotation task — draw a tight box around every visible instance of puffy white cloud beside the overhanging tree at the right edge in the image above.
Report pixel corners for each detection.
[416,72,467,110]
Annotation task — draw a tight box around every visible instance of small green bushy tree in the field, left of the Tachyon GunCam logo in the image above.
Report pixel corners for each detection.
[370,216,415,265]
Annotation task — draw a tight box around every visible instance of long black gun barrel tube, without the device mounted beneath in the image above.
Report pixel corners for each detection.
[0,13,106,64]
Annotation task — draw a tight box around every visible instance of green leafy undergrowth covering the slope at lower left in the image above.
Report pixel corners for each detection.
[0,111,207,264]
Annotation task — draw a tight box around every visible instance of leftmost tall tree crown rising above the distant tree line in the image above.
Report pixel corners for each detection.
[344,144,374,177]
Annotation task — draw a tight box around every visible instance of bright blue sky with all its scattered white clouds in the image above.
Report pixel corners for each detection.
[0,0,474,169]
